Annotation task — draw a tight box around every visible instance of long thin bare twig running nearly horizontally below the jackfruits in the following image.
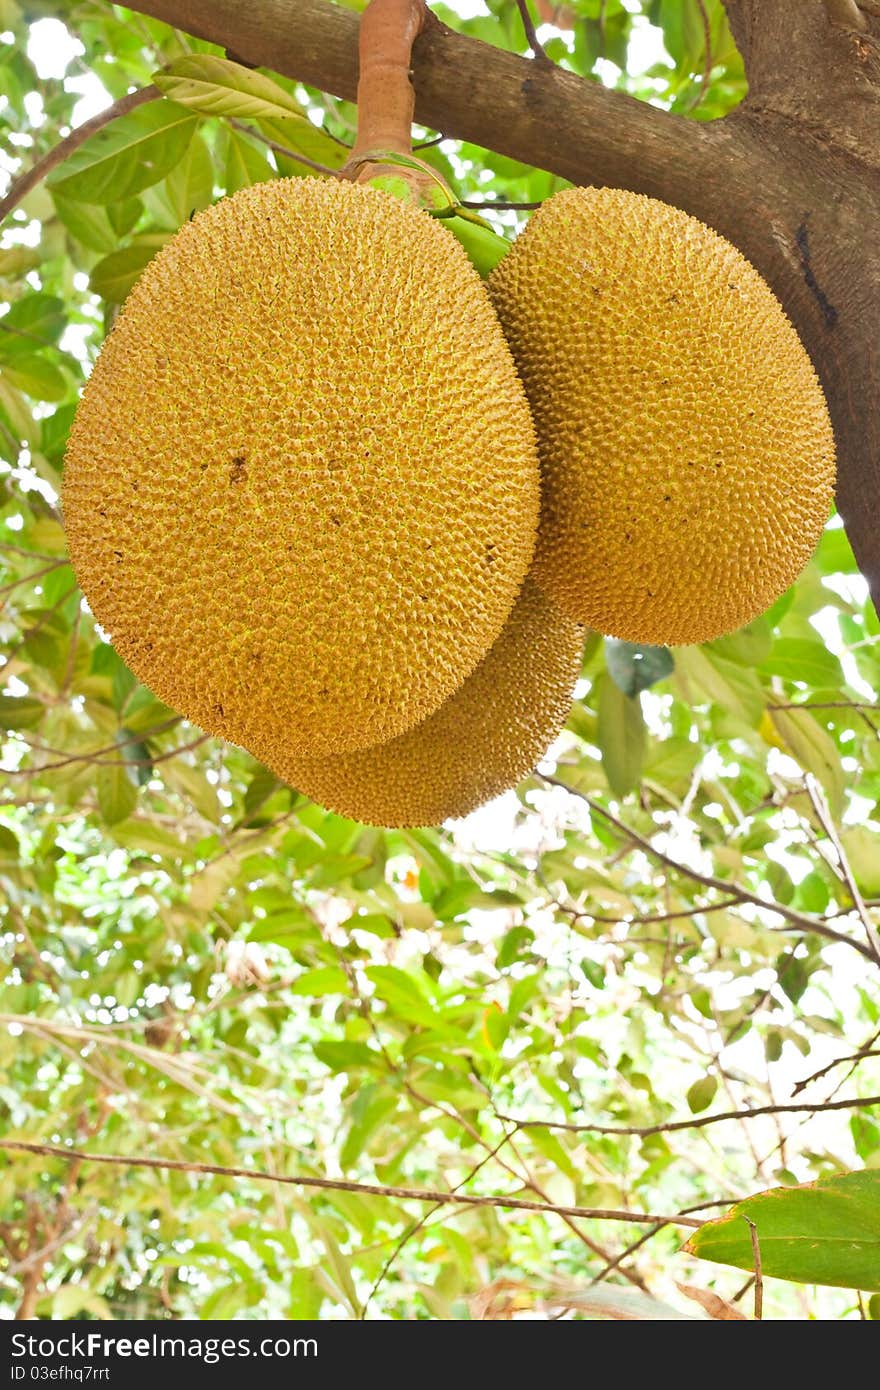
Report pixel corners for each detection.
[0,1138,703,1229]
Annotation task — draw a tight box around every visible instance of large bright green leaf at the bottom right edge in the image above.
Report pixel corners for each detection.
[684,1169,880,1291]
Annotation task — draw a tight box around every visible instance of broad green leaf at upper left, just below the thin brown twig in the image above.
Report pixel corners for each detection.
[46,101,199,203]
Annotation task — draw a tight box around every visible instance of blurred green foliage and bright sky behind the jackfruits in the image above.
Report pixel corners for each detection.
[0,0,880,1318]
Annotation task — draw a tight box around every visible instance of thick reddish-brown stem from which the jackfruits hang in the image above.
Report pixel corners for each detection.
[343,0,428,193]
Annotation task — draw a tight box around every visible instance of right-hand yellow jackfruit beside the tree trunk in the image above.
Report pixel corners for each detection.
[489,188,834,645]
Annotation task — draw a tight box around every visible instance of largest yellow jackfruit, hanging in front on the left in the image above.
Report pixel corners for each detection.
[63,179,539,762]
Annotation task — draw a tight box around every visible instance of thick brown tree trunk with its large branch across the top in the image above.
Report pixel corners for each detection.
[129,0,880,607]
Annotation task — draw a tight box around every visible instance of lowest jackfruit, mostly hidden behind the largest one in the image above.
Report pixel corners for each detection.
[270,578,584,827]
